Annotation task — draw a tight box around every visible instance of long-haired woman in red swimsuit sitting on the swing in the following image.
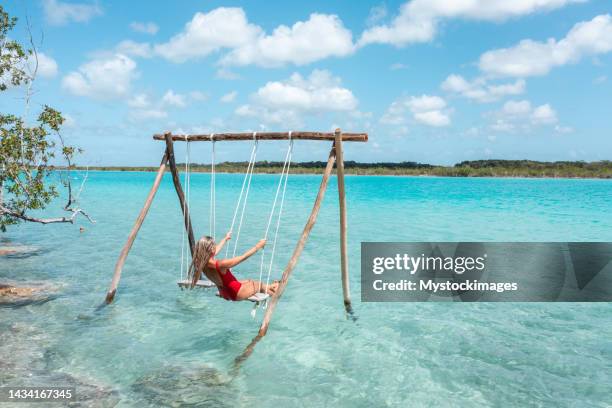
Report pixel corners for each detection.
[189,232,278,301]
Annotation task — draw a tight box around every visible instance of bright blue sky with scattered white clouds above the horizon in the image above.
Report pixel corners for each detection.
[0,0,612,166]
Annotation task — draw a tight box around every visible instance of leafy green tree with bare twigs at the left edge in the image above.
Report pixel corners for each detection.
[0,5,93,231]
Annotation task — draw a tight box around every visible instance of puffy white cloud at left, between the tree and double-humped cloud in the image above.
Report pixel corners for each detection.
[62,54,137,99]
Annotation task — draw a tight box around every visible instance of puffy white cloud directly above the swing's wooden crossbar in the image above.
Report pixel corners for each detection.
[236,70,358,123]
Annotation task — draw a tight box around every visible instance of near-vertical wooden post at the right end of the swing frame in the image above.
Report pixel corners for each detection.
[335,129,353,314]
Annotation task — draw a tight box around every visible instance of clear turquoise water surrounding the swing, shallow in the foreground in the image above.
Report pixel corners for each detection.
[0,172,612,407]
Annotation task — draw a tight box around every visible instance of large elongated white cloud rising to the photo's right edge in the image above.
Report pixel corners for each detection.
[479,14,612,77]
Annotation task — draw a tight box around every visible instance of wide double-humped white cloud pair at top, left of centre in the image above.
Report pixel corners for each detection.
[153,7,355,67]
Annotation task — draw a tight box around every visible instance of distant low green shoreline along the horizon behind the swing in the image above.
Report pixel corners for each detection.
[73,160,612,179]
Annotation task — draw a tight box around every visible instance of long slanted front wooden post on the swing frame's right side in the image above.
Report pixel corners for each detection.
[234,145,336,368]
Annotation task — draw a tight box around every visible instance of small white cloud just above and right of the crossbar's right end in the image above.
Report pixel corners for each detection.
[380,95,451,127]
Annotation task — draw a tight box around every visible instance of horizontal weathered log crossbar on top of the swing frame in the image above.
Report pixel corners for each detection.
[153,132,368,142]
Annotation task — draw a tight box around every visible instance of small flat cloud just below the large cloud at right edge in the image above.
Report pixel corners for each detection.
[441,74,526,103]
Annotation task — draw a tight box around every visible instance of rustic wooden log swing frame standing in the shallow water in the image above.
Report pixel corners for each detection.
[105,129,368,365]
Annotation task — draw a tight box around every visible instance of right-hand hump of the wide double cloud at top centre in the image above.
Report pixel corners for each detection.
[221,14,354,67]
